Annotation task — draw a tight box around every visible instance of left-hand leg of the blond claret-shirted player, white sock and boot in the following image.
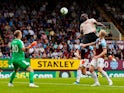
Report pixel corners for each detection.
[89,59,100,86]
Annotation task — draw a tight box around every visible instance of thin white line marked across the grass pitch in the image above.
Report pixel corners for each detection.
[1,82,124,88]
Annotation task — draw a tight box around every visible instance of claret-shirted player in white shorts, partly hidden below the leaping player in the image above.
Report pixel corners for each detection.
[73,46,94,84]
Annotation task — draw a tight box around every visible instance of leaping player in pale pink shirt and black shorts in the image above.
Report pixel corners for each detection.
[80,13,105,58]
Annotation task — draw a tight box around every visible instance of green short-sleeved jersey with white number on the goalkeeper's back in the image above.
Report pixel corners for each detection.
[11,39,25,60]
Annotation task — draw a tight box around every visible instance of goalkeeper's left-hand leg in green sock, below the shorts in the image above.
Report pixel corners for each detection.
[8,64,19,87]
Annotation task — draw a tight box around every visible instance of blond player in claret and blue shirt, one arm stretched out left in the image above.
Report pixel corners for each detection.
[82,30,113,86]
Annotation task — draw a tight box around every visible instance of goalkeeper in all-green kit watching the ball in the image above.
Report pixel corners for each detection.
[8,30,39,87]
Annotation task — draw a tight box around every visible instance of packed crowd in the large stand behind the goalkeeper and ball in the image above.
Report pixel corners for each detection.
[0,0,124,59]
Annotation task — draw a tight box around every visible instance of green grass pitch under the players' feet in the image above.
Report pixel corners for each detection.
[0,78,124,93]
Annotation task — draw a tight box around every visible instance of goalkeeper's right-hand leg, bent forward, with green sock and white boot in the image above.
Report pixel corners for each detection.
[19,60,39,87]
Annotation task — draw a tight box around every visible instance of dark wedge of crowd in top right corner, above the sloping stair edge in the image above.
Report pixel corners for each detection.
[100,0,124,29]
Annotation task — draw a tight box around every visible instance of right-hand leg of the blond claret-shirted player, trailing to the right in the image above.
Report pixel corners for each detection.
[98,58,113,86]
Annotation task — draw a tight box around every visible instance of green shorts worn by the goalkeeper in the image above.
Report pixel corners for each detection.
[12,59,30,70]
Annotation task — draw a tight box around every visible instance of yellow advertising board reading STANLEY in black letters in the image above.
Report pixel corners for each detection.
[30,59,80,70]
